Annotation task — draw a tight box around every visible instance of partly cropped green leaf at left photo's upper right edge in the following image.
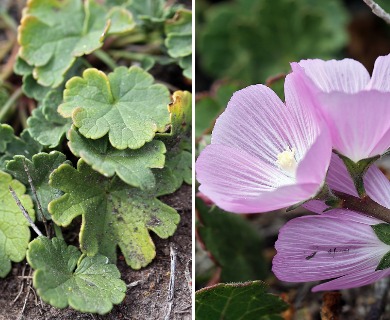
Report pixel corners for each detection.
[165,9,192,78]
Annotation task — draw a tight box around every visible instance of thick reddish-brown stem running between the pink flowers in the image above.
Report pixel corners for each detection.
[333,191,390,223]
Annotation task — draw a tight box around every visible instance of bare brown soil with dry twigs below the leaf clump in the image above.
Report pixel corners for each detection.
[0,185,192,320]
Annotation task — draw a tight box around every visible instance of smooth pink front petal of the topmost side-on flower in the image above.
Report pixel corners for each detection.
[318,91,390,162]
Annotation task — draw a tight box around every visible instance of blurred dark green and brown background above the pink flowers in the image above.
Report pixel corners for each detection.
[196,0,390,92]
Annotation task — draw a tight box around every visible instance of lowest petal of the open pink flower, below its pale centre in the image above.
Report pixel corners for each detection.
[196,144,318,213]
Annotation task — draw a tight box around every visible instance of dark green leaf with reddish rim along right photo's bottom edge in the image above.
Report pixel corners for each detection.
[195,282,287,320]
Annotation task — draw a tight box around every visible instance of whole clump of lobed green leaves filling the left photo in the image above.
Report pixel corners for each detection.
[0,0,192,314]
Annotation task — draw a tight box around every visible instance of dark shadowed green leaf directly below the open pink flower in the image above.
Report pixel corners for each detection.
[196,199,268,282]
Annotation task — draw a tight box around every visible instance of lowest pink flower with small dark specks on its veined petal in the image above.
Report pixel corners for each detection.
[272,209,390,291]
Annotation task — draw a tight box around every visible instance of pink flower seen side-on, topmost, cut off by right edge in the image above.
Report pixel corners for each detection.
[291,55,390,162]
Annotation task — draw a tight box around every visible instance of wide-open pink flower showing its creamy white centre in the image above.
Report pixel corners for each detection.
[196,74,331,213]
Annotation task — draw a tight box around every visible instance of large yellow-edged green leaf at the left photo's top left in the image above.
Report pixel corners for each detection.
[19,0,106,87]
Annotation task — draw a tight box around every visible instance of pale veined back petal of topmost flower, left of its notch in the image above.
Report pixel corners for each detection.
[291,59,370,93]
